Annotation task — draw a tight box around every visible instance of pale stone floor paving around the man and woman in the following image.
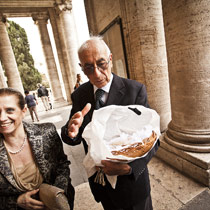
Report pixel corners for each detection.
[25,101,210,210]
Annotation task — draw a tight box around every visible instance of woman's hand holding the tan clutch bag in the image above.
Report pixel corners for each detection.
[17,189,45,210]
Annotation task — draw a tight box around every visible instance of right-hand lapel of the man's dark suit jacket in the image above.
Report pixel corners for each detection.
[106,74,125,106]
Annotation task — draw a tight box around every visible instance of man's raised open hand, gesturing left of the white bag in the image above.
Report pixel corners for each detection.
[68,103,91,138]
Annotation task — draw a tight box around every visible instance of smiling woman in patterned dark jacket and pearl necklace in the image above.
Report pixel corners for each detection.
[0,88,74,210]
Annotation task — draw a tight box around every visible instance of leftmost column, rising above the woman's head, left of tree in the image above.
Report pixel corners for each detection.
[0,16,24,93]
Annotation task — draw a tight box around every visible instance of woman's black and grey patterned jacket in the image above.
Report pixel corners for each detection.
[0,123,74,210]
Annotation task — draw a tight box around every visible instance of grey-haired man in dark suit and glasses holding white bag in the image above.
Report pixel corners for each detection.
[61,37,159,210]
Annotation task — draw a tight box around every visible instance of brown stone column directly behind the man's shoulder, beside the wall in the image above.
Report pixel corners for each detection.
[121,0,171,132]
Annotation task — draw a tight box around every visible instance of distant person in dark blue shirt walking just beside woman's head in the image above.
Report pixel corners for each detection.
[25,90,39,122]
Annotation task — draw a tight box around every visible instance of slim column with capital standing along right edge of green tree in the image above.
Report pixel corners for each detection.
[32,14,64,106]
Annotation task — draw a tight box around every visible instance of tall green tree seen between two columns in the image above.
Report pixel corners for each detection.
[7,21,42,90]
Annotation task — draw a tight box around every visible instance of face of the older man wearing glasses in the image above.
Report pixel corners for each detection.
[79,43,112,88]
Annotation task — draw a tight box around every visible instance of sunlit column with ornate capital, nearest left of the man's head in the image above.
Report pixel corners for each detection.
[56,0,81,87]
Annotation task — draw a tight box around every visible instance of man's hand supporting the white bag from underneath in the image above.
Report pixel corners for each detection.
[100,160,131,176]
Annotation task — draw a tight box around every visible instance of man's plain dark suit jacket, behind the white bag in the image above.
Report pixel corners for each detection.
[61,74,159,208]
